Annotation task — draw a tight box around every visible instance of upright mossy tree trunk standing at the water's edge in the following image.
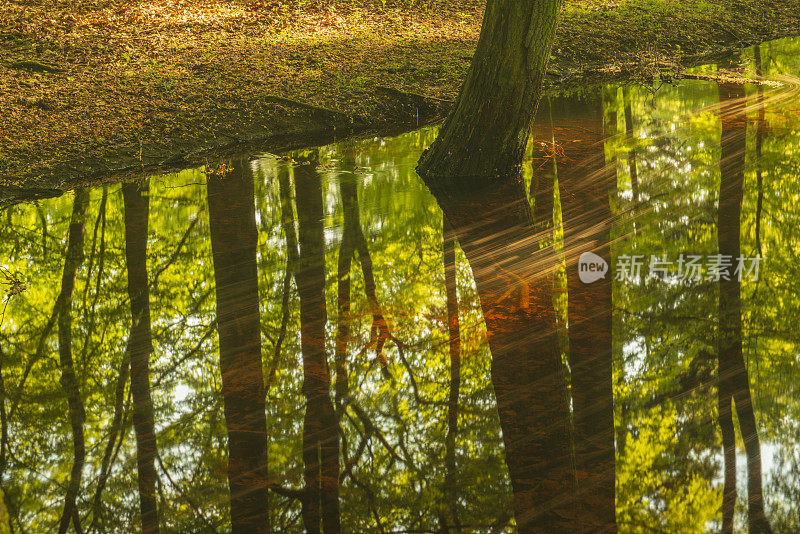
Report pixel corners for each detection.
[417,0,559,179]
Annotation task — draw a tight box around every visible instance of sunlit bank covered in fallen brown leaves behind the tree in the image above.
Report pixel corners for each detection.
[0,0,800,190]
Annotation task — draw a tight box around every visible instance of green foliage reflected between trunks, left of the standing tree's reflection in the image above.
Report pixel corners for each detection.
[0,129,510,531]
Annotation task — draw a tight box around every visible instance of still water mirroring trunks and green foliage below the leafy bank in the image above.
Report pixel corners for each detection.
[0,36,800,533]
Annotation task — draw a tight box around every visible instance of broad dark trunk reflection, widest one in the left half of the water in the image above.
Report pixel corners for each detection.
[208,162,268,533]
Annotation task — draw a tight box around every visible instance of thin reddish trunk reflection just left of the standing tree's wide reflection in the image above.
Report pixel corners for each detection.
[442,219,461,532]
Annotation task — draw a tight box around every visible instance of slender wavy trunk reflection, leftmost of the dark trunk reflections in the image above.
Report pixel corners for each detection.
[57,189,89,534]
